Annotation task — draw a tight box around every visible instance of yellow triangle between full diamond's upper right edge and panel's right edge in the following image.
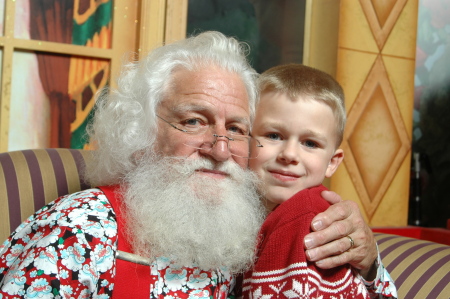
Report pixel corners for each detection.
[382,56,415,139]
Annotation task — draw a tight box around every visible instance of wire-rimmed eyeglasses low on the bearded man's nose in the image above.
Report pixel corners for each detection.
[156,115,263,159]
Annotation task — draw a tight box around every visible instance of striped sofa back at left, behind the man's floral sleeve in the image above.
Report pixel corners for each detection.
[0,149,90,242]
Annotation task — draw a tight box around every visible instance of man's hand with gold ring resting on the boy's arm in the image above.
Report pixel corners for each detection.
[305,191,377,280]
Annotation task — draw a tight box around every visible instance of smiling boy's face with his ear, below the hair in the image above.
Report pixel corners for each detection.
[249,92,344,209]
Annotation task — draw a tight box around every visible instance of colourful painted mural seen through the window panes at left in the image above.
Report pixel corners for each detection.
[9,0,113,150]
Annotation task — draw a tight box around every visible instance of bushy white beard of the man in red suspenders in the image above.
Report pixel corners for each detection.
[124,157,264,273]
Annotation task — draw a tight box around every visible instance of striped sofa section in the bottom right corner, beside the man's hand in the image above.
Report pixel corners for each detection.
[375,233,450,299]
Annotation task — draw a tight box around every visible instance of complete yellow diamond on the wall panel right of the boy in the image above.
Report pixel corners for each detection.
[342,56,411,219]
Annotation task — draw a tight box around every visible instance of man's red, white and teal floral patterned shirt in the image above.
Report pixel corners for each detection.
[0,189,234,299]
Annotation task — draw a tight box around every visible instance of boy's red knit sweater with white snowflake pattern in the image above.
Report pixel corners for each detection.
[243,186,369,299]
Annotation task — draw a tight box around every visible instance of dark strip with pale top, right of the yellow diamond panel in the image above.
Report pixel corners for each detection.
[410,0,450,227]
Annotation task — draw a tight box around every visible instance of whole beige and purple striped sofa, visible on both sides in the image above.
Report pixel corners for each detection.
[0,149,450,299]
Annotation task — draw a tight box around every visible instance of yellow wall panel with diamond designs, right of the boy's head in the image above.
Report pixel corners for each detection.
[331,0,418,226]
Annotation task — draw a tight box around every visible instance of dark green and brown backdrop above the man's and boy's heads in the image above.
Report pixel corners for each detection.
[187,0,306,73]
